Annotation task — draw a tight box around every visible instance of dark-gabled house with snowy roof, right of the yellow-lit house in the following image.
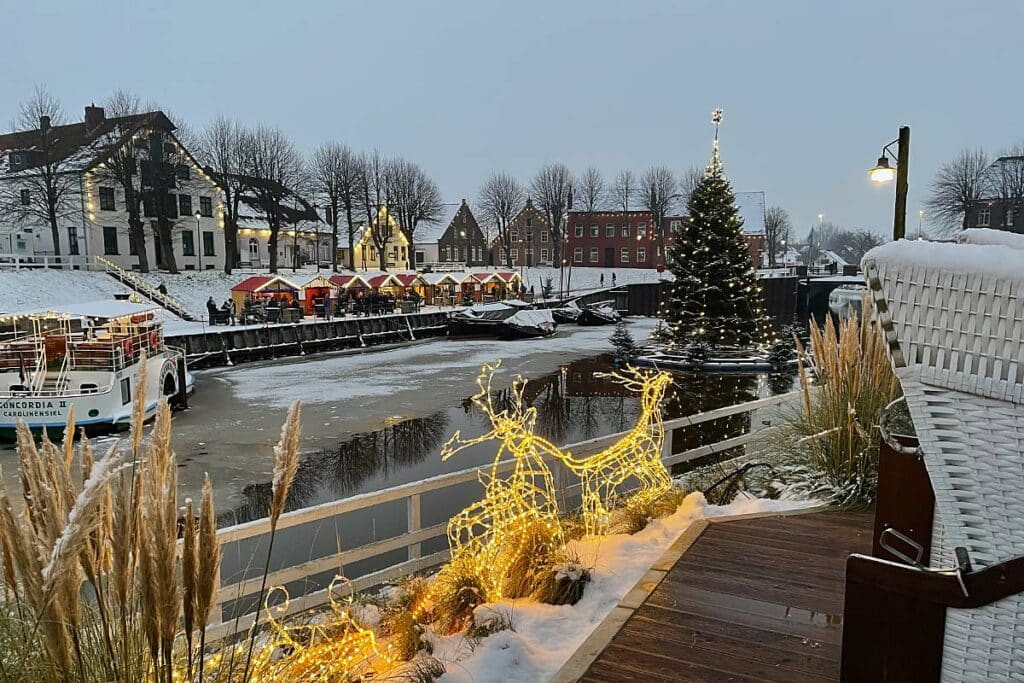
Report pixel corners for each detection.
[416,200,490,268]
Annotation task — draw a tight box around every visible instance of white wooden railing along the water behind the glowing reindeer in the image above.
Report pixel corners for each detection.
[208,391,801,639]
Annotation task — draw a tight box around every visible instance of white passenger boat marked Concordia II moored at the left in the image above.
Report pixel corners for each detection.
[0,300,195,440]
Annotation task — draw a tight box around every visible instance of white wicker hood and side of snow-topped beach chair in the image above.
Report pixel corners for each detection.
[862,239,1024,681]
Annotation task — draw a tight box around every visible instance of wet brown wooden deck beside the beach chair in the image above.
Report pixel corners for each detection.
[581,512,871,683]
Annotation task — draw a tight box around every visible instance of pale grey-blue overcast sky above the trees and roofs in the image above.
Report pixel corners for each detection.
[0,0,1024,234]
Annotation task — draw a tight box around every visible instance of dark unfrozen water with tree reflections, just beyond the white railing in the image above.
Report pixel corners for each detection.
[221,355,793,525]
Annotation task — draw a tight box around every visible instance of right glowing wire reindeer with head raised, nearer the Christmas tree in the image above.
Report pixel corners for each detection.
[551,368,672,533]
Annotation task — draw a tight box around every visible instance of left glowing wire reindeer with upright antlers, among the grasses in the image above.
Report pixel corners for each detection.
[441,361,564,600]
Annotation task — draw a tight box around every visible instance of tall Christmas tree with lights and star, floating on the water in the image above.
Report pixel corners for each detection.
[662,110,775,348]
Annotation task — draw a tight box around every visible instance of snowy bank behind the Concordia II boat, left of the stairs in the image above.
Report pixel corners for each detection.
[0,268,131,313]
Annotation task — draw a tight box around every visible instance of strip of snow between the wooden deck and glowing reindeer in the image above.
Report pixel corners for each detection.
[433,493,816,683]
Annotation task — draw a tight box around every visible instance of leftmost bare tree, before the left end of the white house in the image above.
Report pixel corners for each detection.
[0,86,81,256]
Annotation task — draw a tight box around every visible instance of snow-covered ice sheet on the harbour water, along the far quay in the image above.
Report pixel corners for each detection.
[218,318,658,409]
